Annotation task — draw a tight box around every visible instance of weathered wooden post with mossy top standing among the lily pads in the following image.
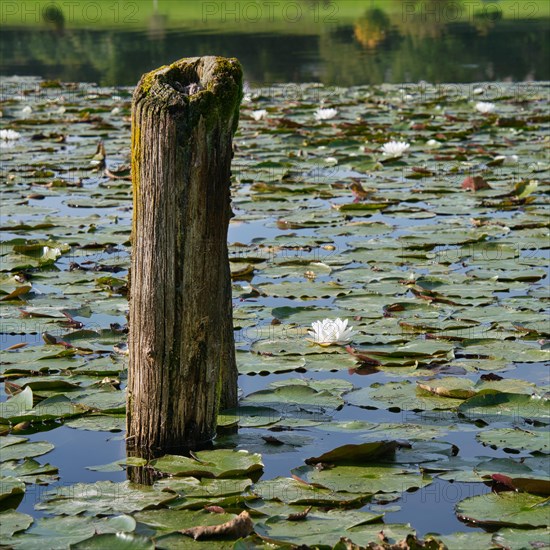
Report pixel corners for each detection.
[127,57,242,452]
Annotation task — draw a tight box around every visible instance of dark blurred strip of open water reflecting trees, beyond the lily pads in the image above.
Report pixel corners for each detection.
[0,8,550,85]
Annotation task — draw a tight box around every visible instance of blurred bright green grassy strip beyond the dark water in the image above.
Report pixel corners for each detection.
[0,0,550,34]
